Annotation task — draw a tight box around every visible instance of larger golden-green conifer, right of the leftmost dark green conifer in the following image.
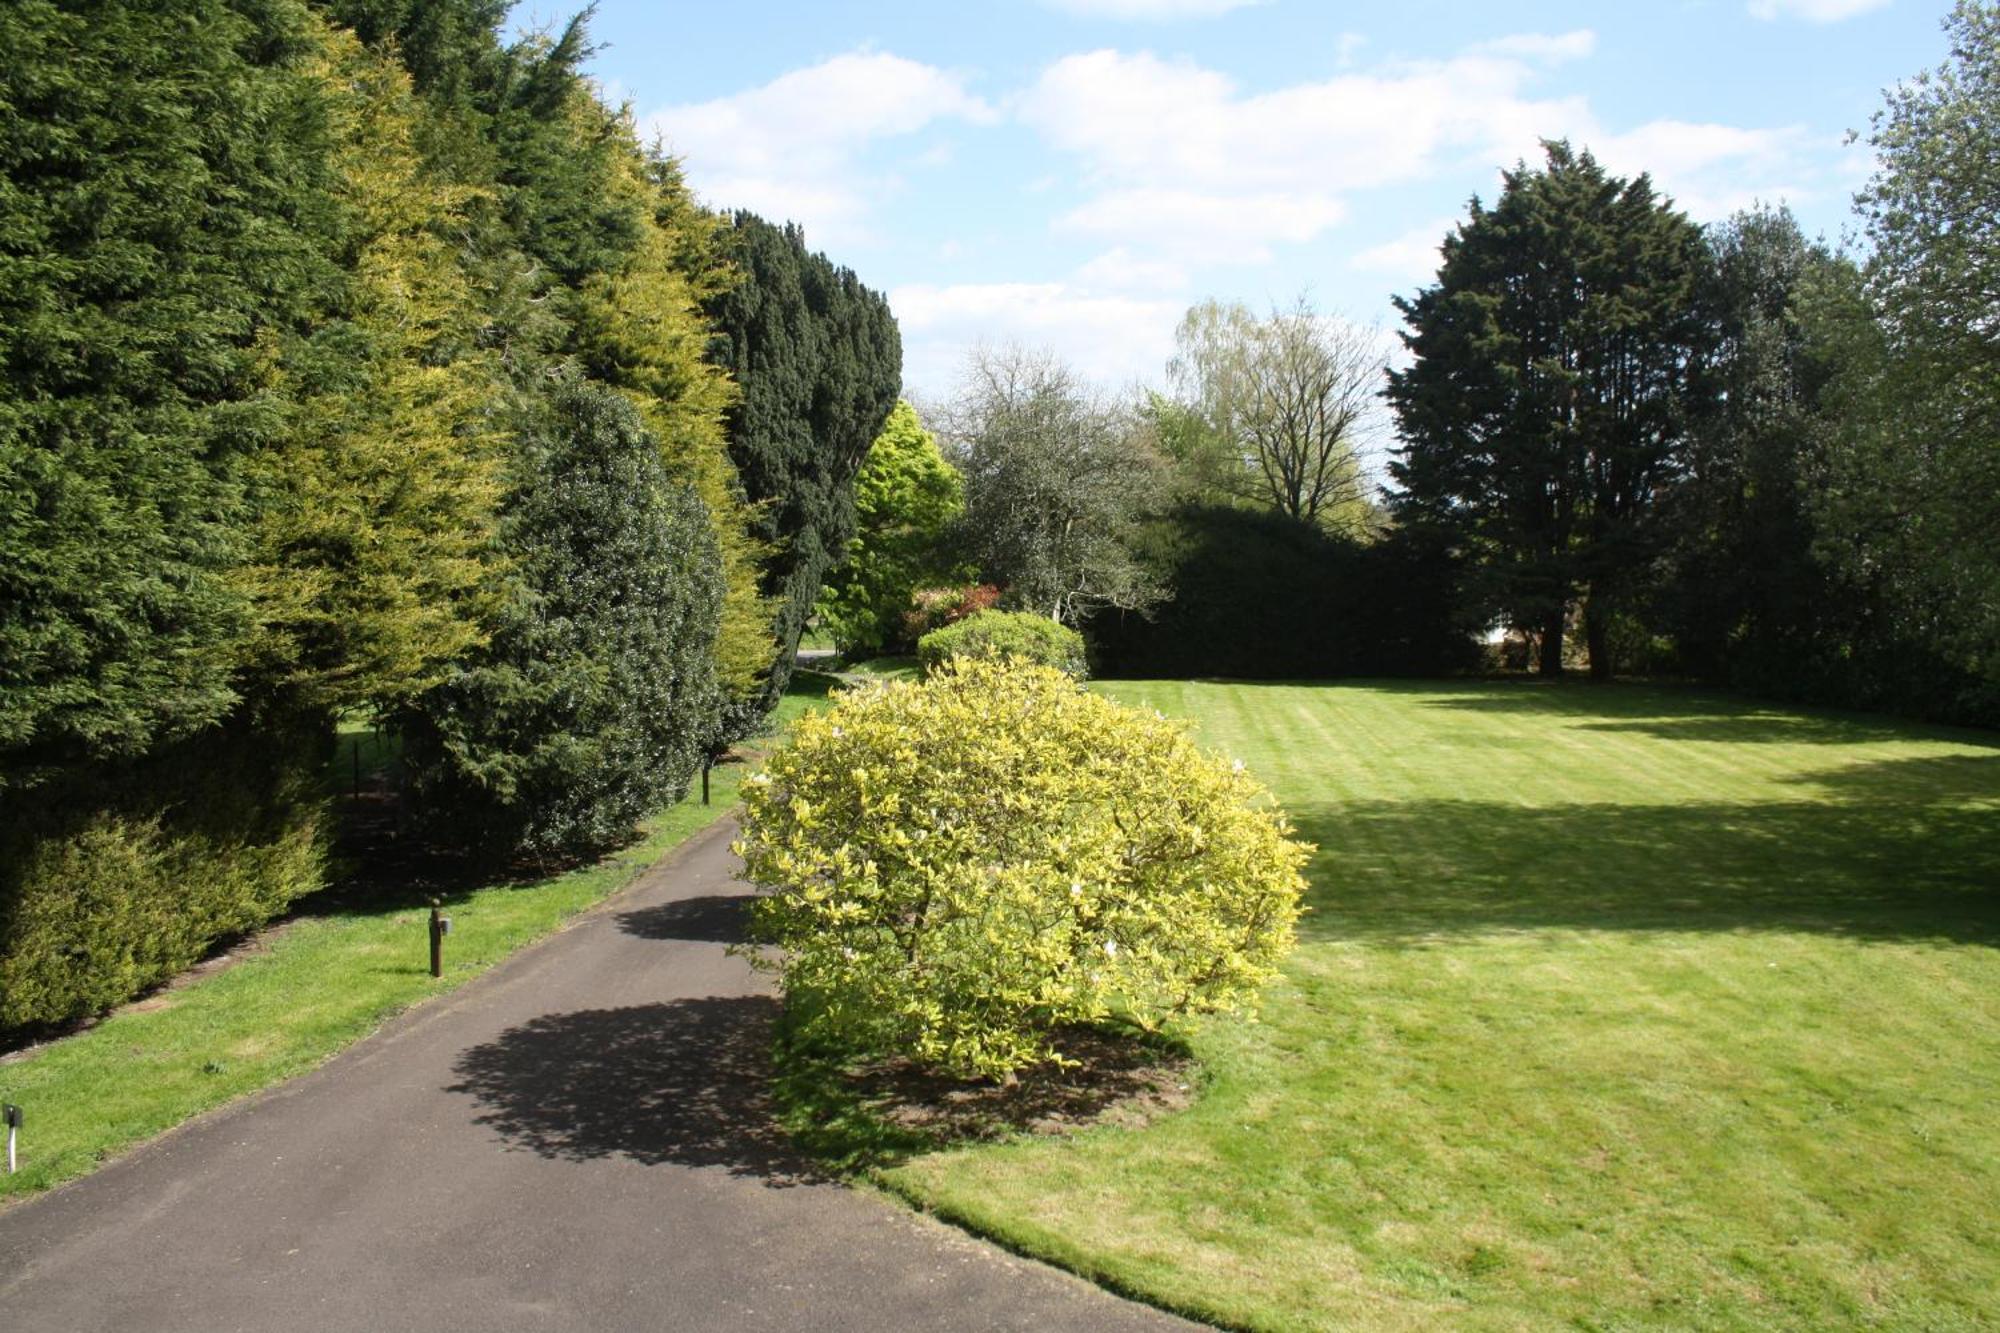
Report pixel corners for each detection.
[244,28,502,709]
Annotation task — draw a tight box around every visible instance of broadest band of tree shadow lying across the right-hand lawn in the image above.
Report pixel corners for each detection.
[1292,755,2000,945]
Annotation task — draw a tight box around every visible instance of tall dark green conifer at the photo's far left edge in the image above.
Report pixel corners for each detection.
[0,2,338,783]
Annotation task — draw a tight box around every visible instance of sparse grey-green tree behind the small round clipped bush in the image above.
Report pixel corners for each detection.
[938,348,1166,624]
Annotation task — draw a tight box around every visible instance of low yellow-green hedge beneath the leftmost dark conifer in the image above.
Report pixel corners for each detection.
[0,719,330,1033]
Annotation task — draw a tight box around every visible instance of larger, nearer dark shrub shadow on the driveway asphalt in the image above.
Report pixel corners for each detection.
[448,995,828,1187]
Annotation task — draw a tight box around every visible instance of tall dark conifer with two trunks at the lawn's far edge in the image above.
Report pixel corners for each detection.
[1388,142,1714,677]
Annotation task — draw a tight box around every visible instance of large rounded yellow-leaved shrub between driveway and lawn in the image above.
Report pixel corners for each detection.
[736,658,1312,1079]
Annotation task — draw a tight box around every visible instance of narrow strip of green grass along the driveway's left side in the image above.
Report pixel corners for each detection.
[0,673,828,1207]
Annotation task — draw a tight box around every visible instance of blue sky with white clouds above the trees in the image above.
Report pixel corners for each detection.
[564,0,1948,396]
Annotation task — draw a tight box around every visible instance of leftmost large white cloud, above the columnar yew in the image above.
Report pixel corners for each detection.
[644,52,996,246]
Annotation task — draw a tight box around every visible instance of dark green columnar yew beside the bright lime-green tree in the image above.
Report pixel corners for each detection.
[708,212,902,735]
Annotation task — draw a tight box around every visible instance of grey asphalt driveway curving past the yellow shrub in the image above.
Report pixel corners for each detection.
[0,825,1188,1333]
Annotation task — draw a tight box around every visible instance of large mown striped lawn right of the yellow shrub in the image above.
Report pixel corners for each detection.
[880,683,2000,1329]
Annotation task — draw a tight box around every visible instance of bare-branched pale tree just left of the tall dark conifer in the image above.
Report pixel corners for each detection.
[1170,298,1384,528]
